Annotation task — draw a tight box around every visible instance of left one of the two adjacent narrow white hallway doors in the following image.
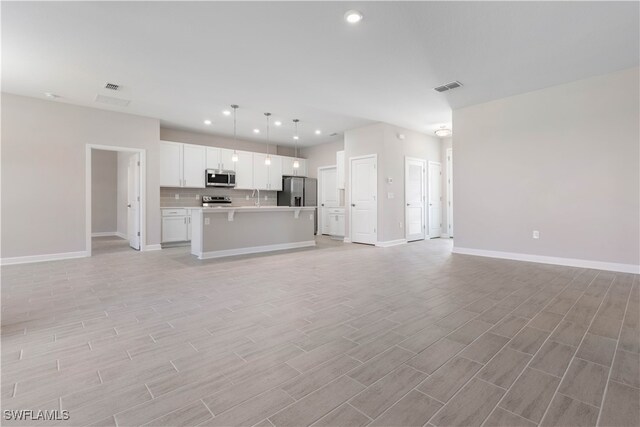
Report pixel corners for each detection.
[404,158,425,242]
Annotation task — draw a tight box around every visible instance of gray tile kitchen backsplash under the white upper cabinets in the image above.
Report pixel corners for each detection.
[160,187,278,208]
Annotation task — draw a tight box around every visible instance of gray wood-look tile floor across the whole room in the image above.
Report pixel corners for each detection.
[1,239,640,426]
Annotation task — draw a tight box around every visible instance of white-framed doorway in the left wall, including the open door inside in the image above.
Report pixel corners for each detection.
[85,144,146,256]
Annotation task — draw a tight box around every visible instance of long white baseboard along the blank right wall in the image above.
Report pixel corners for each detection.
[453,246,640,274]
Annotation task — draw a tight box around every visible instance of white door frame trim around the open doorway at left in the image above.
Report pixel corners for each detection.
[84,144,147,257]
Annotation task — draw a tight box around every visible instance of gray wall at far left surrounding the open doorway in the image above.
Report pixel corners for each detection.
[2,93,160,257]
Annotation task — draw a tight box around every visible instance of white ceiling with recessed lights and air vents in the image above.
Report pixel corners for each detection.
[1,1,640,145]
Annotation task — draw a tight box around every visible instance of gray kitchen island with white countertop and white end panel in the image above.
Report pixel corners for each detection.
[191,206,316,259]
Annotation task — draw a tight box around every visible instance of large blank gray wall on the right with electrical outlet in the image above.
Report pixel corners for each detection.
[453,68,640,265]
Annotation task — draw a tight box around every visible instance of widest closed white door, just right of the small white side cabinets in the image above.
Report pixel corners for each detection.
[349,156,378,245]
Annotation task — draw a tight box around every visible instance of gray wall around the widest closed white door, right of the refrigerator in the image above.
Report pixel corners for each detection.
[344,123,441,242]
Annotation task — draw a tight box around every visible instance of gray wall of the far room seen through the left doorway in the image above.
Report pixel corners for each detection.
[91,150,118,233]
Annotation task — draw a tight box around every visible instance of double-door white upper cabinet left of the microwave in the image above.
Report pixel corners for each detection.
[160,141,206,188]
